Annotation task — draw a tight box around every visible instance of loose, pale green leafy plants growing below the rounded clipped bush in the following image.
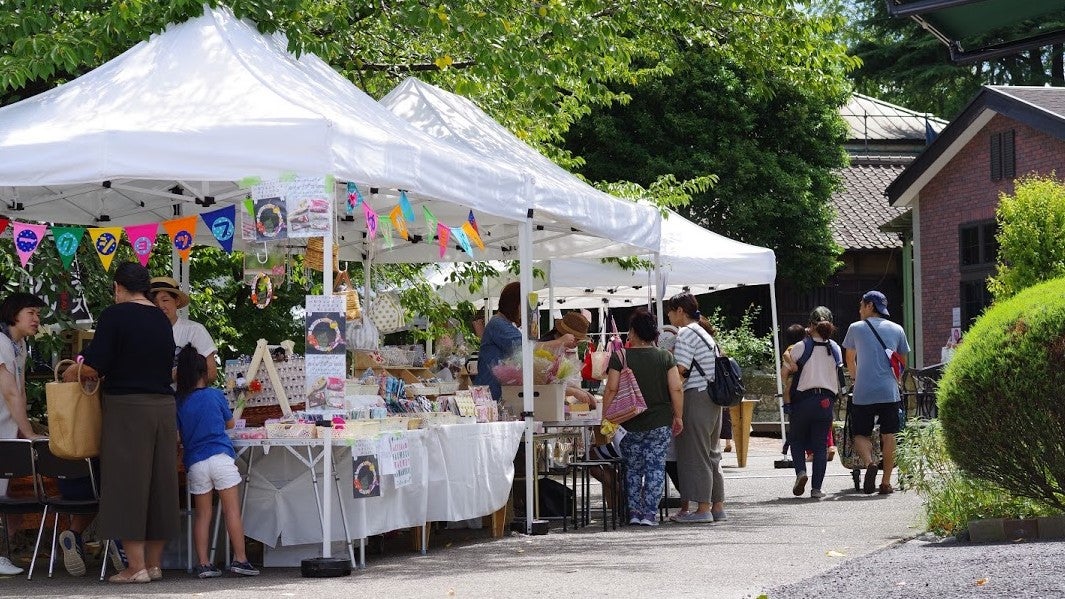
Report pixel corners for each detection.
[896,420,1053,535]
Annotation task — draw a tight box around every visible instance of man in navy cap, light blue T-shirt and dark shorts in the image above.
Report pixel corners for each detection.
[843,291,910,495]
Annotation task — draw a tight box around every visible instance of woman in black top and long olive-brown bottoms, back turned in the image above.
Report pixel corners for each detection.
[63,262,179,583]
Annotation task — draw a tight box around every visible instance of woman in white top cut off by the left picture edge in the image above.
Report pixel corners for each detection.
[0,292,46,576]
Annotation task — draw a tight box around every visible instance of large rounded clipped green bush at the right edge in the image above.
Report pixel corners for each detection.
[937,278,1065,509]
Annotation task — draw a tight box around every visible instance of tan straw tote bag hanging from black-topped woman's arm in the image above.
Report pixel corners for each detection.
[45,360,103,459]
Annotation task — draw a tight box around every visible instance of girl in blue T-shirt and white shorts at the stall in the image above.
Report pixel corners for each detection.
[176,343,259,578]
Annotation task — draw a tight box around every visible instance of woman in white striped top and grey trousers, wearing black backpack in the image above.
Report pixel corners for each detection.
[667,293,725,523]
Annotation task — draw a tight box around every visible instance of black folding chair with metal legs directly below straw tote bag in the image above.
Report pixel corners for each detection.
[27,439,111,580]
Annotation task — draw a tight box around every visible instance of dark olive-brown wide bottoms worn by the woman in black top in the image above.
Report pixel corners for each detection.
[98,393,180,540]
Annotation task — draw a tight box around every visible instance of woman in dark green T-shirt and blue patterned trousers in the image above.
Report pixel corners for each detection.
[603,308,684,527]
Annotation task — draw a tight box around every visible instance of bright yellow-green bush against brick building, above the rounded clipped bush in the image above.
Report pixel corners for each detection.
[987,175,1065,302]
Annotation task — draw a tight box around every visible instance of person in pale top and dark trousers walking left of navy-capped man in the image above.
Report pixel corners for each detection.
[782,306,842,499]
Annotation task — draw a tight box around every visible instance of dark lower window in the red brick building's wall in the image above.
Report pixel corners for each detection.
[959,221,998,328]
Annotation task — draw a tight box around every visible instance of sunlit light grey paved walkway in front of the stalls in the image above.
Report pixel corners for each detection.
[0,438,919,599]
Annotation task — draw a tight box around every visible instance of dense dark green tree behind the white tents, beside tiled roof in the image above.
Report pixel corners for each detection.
[567,50,847,287]
